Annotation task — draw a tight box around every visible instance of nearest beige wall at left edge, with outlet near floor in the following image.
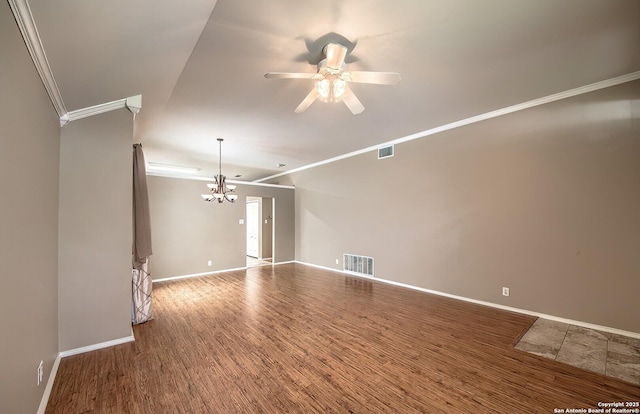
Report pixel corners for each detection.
[0,2,60,414]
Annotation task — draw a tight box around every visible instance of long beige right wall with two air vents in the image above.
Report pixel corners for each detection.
[280,81,640,333]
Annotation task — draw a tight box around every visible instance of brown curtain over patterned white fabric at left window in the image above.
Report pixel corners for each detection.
[131,144,153,325]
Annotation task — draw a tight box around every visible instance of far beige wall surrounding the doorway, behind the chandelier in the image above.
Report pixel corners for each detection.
[147,176,295,279]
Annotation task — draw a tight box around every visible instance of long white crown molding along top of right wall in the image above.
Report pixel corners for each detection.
[253,71,640,183]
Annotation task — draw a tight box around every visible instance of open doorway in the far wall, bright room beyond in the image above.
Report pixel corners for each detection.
[246,196,275,267]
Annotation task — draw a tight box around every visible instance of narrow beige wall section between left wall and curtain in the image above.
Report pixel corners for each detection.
[58,109,133,351]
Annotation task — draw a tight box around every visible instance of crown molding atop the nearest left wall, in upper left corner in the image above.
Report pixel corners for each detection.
[9,0,67,118]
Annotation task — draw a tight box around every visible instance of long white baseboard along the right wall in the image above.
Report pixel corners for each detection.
[295,260,640,339]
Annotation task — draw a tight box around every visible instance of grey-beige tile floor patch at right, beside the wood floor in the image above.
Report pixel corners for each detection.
[516,318,640,385]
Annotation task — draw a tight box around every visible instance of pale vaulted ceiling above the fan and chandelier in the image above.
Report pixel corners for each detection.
[29,0,640,180]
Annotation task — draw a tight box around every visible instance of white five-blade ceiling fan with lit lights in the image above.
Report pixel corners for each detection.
[264,43,400,115]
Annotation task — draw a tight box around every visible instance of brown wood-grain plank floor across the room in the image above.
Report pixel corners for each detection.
[46,264,640,414]
